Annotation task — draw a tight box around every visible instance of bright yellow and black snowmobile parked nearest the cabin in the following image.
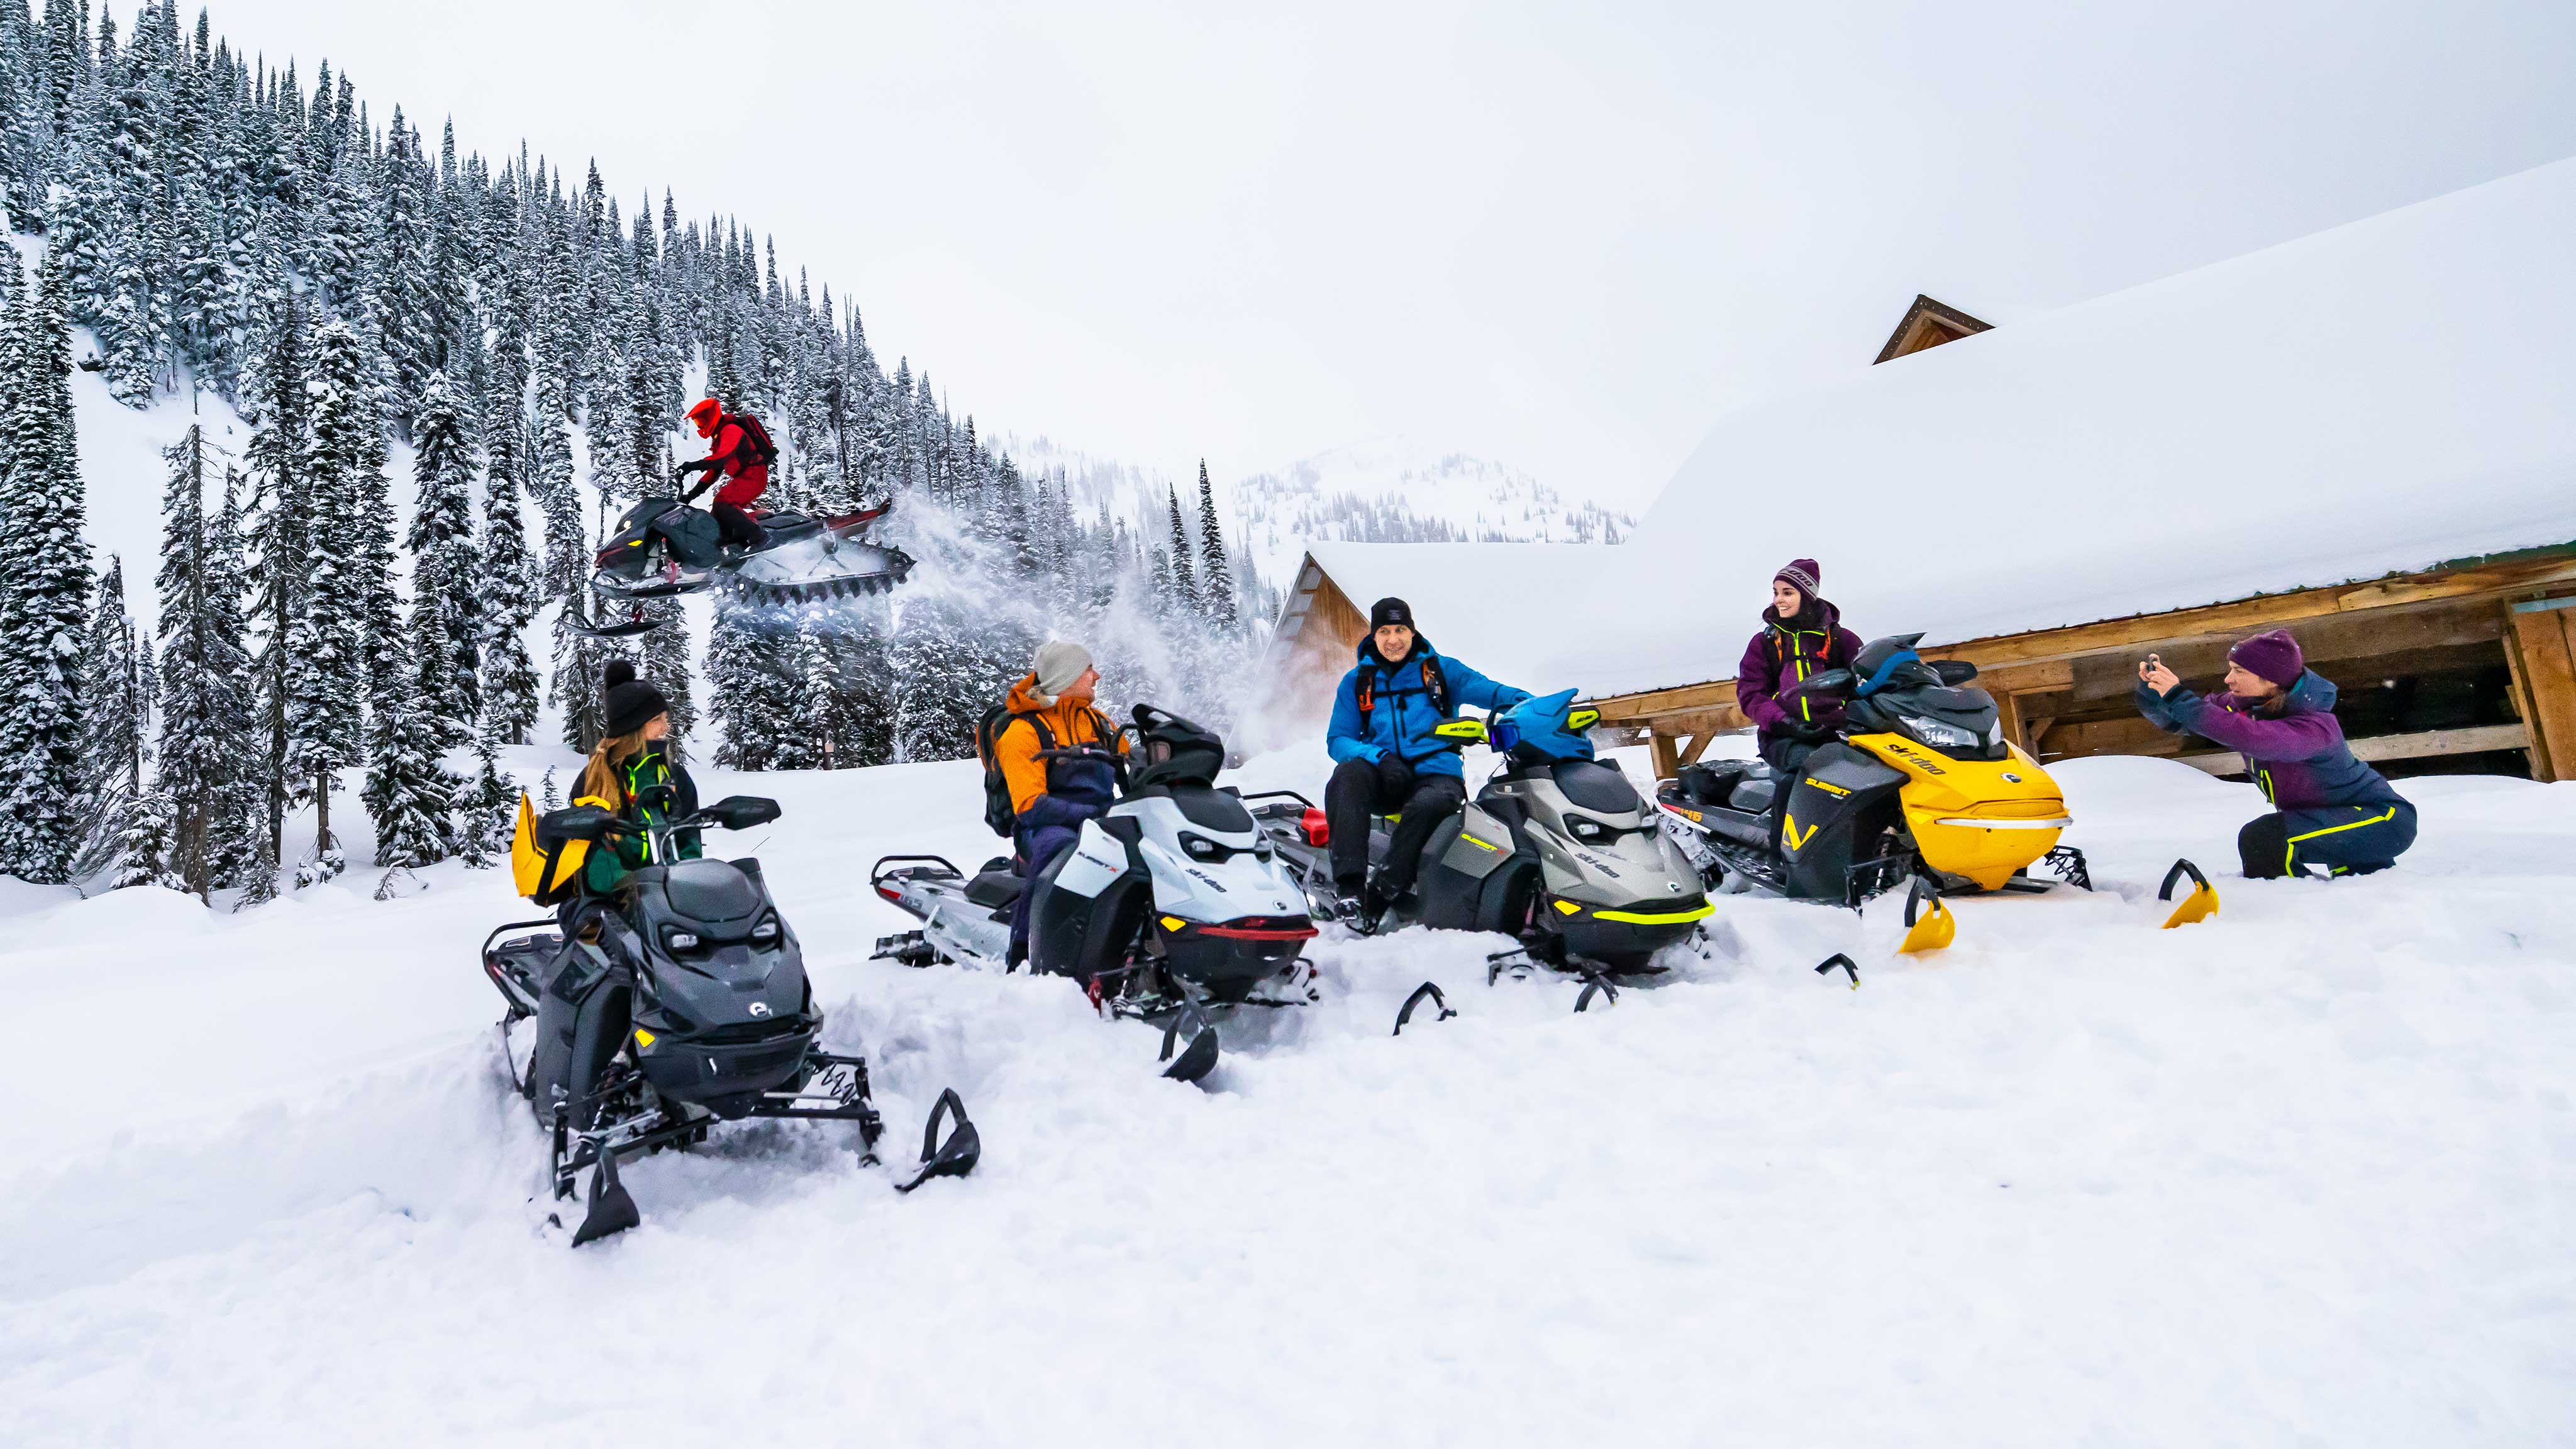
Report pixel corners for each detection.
[1657,635,2092,908]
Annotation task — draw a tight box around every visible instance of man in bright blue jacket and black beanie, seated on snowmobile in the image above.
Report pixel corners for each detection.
[1324,598,1530,931]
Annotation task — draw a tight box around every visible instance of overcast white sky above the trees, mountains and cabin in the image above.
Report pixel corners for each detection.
[196,0,2576,502]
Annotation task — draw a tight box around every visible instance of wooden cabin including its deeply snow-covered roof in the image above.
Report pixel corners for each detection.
[1265,162,2576,781]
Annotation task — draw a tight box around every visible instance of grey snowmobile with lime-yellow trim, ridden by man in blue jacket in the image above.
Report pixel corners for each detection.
[1252,689,1711,980]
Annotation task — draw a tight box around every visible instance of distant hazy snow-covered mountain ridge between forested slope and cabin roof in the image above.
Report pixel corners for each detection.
[1008,436,1636,586]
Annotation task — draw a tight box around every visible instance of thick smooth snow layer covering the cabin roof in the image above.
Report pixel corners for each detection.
[1282,160,2576,694]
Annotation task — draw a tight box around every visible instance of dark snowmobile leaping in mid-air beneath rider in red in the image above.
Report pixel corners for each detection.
[582,472,912,640]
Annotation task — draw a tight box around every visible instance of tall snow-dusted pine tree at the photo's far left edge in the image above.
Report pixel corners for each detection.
[0,253,90,882]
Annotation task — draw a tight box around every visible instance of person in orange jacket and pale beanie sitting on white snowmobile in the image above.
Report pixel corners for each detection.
[992,640,1126,964]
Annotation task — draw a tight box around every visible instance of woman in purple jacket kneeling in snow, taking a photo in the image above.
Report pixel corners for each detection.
[2138,629,2414,877]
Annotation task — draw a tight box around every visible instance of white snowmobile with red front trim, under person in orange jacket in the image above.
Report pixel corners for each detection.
[868,704,1316,1080]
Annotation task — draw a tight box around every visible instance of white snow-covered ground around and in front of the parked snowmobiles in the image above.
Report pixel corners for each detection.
[0,748,2576,1446]
